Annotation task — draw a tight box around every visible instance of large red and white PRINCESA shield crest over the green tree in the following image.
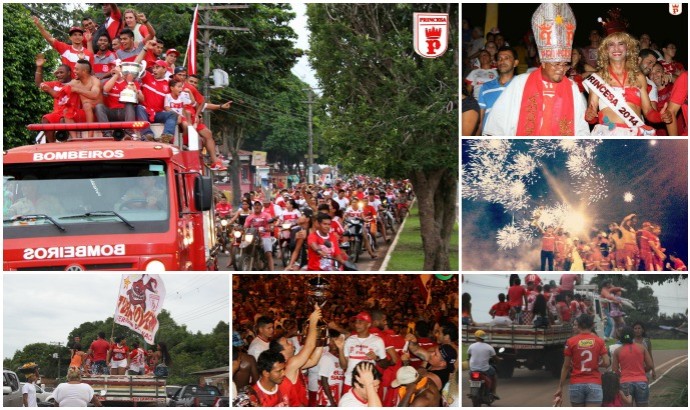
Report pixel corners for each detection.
[414,13,450,58]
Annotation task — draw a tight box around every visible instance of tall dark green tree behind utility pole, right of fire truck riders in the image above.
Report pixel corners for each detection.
[203,3,301,204]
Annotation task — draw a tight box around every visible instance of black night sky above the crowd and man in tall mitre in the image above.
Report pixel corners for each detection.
[462,2,688,65]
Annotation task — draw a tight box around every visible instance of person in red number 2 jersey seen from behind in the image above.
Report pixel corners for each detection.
[554,315,610,407]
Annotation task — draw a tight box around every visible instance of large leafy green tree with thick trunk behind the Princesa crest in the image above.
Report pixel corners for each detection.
[307,4,459,270]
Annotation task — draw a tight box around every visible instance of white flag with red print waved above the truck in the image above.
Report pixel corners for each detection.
[115,273,165,344]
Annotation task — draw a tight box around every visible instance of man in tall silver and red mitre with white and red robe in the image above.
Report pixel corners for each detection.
[483,3,589,136]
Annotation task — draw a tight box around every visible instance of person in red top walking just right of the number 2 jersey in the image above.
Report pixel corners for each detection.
[611,327,656,407]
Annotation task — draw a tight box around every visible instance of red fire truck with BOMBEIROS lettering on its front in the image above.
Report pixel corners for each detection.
[3,122,215,271]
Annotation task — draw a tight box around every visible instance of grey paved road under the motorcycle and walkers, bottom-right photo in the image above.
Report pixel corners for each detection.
[462,350,688,407]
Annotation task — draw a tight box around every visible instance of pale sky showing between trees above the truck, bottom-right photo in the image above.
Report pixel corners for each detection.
[460,273,688,322]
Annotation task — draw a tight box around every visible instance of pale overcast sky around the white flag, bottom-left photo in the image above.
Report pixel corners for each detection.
[2,273,230,358]
